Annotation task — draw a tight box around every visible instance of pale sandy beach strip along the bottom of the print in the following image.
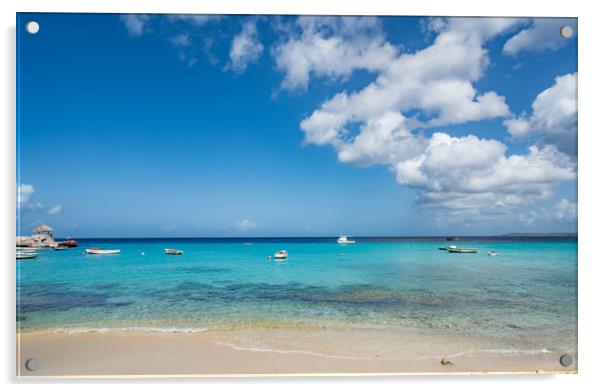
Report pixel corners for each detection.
[17,331,577,377]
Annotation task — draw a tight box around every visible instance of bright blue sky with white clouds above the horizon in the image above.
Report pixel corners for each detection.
[17,14,577,237]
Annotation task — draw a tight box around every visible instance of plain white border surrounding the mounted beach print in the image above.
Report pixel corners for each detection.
[0,0,602,392]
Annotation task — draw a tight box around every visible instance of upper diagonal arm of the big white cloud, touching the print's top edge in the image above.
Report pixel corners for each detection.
[298,18,520,150]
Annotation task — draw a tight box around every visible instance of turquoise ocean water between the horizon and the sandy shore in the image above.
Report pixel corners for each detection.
[17,237,577,351]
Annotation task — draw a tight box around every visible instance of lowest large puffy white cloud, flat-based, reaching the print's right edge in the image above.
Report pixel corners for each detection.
[394,133,575,214]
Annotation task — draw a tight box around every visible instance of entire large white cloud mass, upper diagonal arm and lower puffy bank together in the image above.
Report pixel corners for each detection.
[292,18,576,222]
